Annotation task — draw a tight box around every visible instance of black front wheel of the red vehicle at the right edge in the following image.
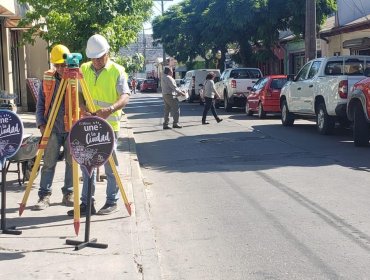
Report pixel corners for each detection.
[353,105,370,147]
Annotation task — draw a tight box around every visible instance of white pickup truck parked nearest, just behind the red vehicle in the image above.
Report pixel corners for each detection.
[280,55,370,134]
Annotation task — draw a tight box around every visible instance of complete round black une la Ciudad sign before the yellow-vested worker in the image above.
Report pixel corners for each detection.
[69,117,114,176]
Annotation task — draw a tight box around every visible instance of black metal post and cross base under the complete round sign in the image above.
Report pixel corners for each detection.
[66,176,108,250]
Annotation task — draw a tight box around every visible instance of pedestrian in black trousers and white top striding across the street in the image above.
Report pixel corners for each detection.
[202,72,222,124]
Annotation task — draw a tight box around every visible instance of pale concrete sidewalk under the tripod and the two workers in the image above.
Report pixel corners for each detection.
[0,113,160,280]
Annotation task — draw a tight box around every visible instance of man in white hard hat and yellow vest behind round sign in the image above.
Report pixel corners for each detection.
[67,34,130,216]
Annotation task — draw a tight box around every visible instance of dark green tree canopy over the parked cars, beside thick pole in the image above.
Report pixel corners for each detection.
[152,0,336,66]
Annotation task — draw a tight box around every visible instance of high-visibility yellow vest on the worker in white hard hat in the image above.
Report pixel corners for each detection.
[81,61,126,131]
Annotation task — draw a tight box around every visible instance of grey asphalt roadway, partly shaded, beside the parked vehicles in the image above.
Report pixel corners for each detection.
[126,93,370,280]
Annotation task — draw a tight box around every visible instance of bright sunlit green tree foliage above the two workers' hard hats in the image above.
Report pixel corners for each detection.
[18,0,153,57]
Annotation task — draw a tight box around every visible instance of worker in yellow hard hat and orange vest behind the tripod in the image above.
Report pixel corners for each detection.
[33,45,73,210]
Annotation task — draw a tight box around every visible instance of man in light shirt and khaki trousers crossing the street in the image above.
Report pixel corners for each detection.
[161,67,185,129]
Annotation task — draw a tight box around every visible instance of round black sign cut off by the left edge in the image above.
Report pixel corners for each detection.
[0,110,23,166]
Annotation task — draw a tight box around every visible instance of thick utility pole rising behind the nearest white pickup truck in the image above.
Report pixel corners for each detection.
[305,0,316,62]
